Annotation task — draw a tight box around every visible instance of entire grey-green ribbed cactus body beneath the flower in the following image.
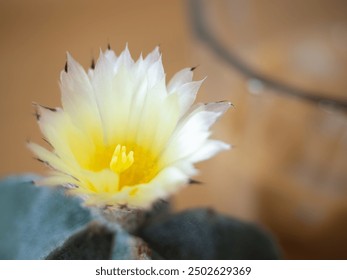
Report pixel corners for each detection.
[0,175,281,260]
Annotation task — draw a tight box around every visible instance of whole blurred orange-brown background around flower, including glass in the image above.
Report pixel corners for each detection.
[0,0,347,259]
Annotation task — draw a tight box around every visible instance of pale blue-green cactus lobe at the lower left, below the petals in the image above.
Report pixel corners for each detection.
[0,175,91,260]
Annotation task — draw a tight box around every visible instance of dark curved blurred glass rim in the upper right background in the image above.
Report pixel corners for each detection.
[188,0,347,113]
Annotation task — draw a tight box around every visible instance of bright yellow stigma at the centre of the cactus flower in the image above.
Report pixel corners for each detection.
[110,144,134,174]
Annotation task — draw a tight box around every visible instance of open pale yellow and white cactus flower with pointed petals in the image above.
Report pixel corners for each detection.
[28,48,230,208]
